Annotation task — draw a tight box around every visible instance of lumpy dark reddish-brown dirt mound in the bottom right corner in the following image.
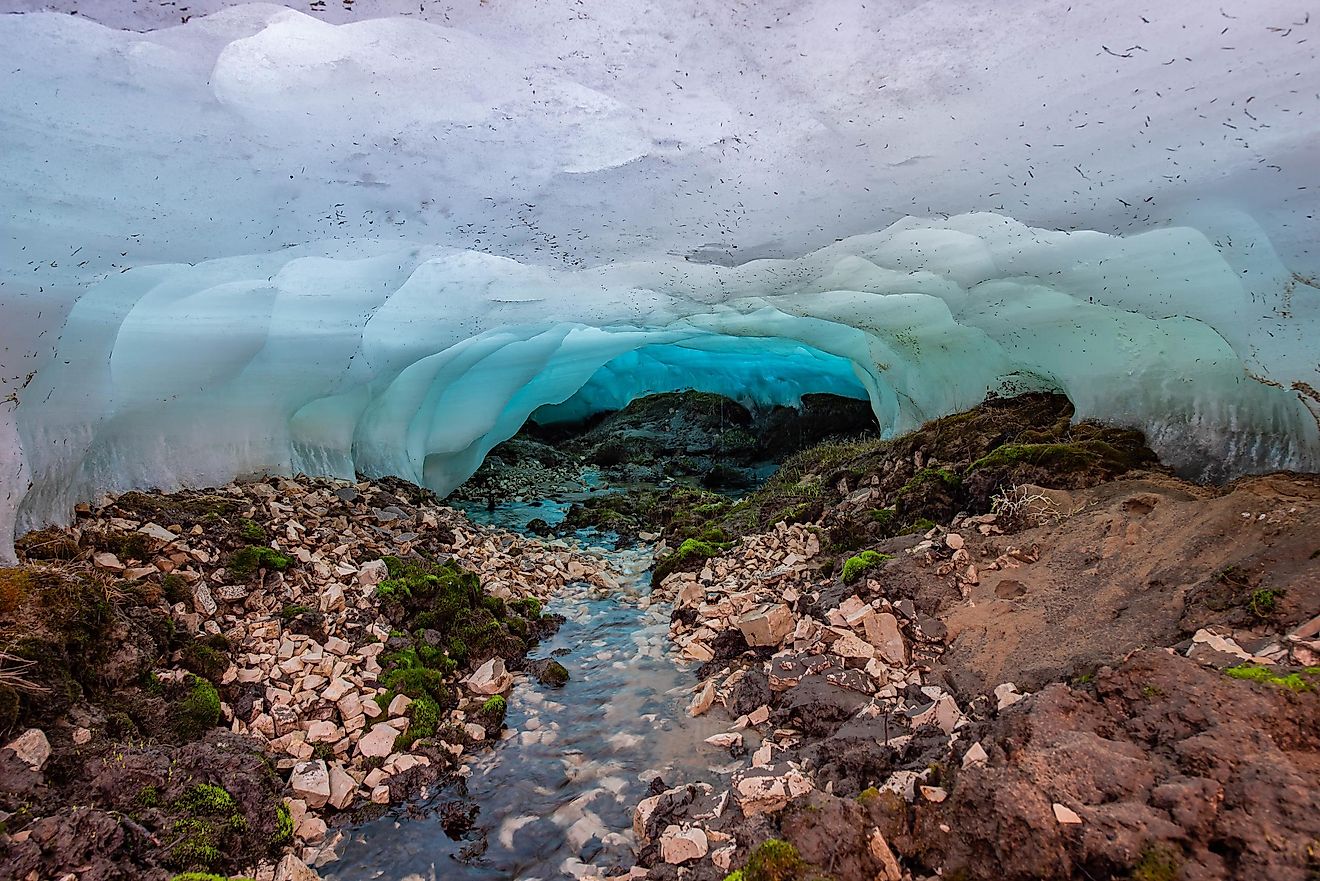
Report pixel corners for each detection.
[913,651,1320,881]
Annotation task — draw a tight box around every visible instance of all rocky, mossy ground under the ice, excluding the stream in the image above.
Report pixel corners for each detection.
[0,395,1320,881]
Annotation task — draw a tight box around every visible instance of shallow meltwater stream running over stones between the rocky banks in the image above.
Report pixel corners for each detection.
[321,505,729,881]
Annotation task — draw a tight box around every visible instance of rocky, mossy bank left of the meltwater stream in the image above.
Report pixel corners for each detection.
[0,479,614,881]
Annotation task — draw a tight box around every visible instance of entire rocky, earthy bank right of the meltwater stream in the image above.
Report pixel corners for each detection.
[607,396,1320,881]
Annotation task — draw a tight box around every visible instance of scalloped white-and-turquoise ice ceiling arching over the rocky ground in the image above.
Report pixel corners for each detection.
[0,0,1320,557]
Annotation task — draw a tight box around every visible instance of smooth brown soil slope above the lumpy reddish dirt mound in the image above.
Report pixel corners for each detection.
[886,474,1320,693]
